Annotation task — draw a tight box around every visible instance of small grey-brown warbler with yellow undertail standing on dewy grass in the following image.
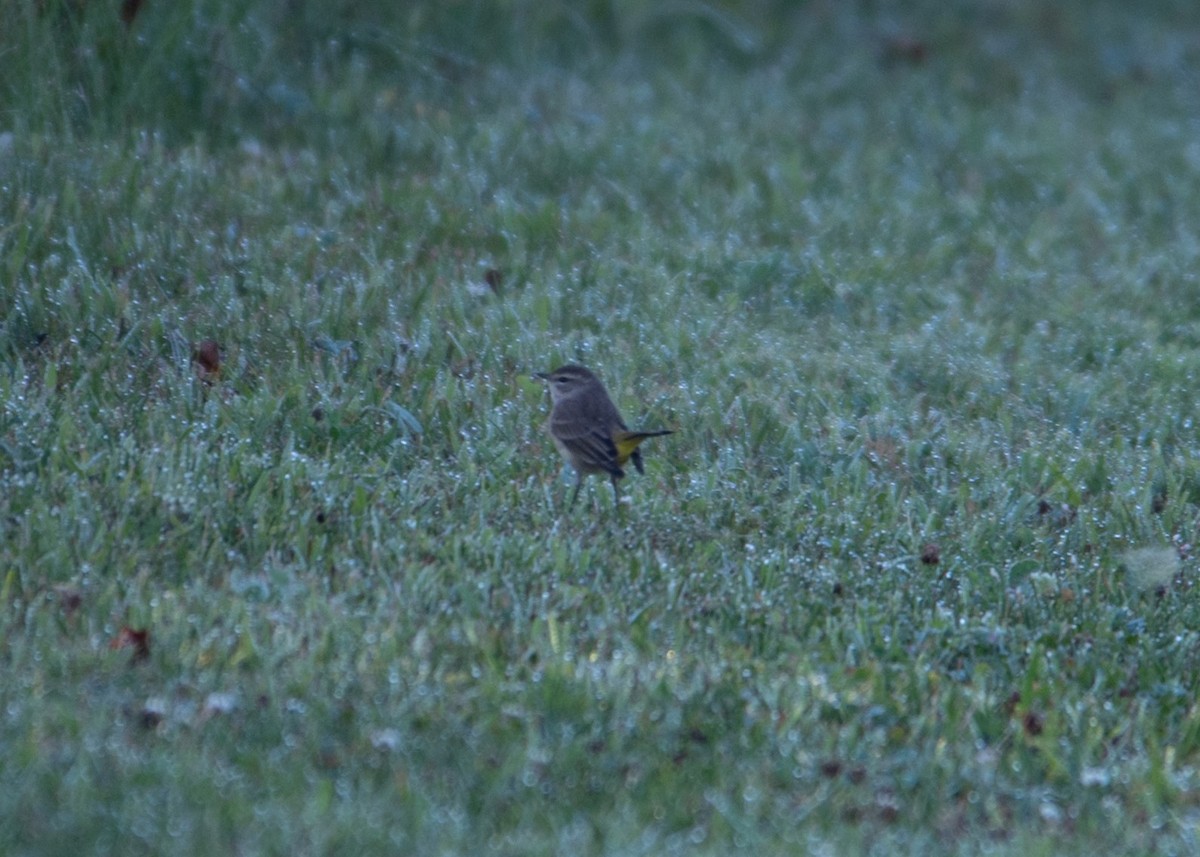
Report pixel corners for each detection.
[534,366,673,509]
